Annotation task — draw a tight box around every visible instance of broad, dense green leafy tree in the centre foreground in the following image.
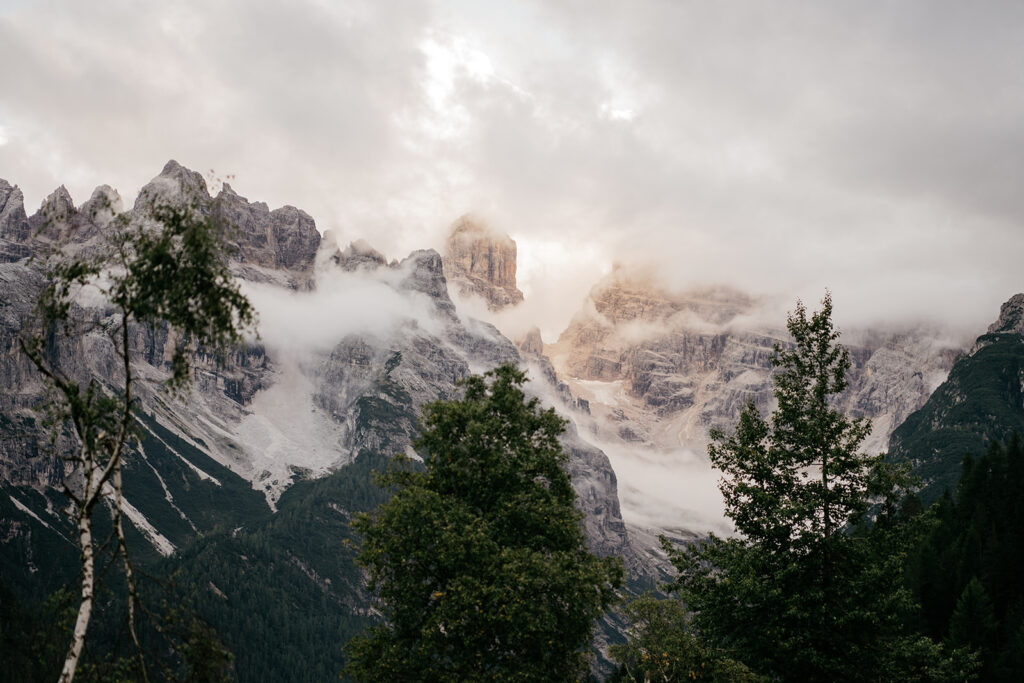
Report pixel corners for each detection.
[346,366,623,681]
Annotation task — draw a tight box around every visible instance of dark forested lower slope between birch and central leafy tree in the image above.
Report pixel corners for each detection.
[166,453,387,682]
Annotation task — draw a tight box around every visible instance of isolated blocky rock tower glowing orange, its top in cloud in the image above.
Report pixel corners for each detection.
[442,215,522,310]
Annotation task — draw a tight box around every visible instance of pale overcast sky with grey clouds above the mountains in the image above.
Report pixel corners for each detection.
[0,0,1024,341]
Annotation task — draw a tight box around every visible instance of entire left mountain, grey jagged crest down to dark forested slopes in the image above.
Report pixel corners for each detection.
[0,162,645,680]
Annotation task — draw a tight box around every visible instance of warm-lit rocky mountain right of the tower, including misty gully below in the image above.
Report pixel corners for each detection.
[544,268,956,533]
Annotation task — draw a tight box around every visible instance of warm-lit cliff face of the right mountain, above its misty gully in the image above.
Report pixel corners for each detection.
[545,272,957,454]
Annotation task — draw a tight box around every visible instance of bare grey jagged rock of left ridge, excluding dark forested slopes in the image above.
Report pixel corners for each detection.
[0,161,638,569]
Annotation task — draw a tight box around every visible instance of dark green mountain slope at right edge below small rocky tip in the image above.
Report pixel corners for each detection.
[889,294,1024,502]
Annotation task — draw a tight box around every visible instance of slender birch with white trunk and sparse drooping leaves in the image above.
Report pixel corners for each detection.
[19,194,255,683]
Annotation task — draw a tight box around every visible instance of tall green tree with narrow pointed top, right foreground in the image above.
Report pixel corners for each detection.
[663,296,952,681]
